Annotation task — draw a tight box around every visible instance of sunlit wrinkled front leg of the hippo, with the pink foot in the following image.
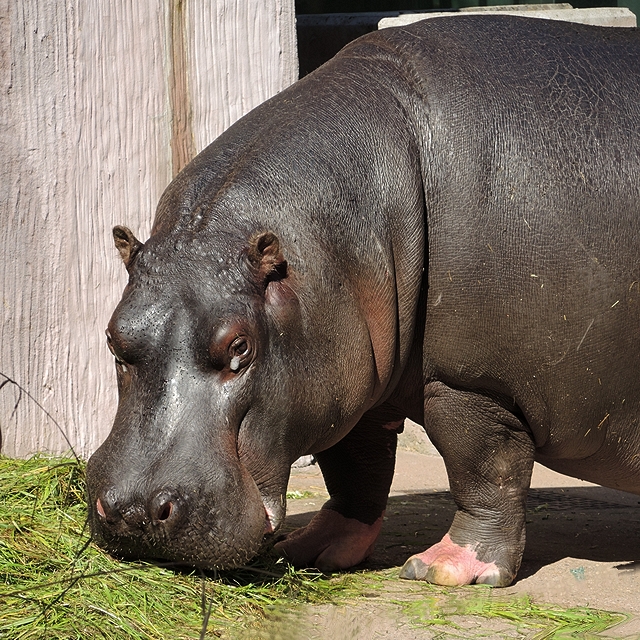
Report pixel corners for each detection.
[400,382,534,586]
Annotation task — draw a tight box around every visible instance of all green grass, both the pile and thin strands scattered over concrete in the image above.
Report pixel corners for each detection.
[0,456,624,640]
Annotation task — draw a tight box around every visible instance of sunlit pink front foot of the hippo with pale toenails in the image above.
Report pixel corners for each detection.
[400,534,513,587]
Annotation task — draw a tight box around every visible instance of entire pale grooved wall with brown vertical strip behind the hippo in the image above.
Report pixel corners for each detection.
[0,0,297,456]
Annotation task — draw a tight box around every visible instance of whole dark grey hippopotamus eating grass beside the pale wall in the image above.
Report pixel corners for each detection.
[87,16,640,586]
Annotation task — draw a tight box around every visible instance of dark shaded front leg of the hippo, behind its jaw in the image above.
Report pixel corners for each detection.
[275,408,403,572]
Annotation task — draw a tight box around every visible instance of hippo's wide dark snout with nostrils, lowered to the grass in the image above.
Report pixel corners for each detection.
[87,448,284,569]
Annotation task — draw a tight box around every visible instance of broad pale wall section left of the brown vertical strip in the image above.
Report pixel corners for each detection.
[0,0,170,455]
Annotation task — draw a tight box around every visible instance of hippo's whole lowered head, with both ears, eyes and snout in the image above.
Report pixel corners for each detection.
[87,216,371,569]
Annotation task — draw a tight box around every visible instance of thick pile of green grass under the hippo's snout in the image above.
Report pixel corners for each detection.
[0,457,353,640]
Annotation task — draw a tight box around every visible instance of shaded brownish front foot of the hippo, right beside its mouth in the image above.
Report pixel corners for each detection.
[274,509,382,573]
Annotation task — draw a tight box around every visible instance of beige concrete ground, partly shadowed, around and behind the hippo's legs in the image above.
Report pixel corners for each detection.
[283,425,640,640]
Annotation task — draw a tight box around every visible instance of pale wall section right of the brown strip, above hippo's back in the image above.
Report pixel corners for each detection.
[186,0,298,152]
